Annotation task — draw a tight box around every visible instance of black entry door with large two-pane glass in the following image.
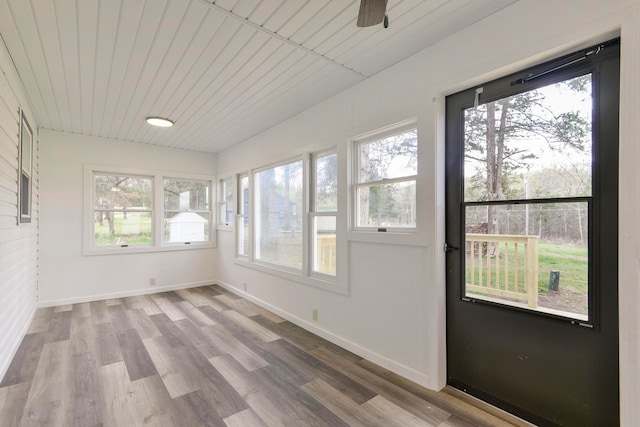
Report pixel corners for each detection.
[445,40,619,426]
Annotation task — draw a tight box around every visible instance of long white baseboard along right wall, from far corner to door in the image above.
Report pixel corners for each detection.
[216,280,435,390]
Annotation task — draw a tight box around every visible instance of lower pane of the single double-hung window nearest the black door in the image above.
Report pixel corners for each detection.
[356,180,416,227]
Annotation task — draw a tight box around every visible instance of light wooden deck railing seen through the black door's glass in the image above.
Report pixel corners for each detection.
[465,233,538,308]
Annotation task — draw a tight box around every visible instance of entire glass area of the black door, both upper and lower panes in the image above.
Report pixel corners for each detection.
[464,74,593,320]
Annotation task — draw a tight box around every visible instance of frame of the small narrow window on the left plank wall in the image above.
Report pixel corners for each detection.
[17,109,34,225]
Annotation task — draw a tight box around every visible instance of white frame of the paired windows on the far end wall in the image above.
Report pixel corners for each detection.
[82,164,217,256]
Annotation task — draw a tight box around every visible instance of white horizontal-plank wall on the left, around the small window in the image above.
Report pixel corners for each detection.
[0,39,39,380]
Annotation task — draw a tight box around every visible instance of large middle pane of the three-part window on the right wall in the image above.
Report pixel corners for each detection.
[254,161,303,269]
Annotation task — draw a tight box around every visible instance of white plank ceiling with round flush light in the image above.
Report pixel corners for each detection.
[0,0,516,153]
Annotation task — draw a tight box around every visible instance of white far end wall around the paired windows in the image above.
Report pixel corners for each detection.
[38,130,215,306]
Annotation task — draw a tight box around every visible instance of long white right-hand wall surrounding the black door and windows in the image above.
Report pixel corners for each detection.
[217,0,640,425]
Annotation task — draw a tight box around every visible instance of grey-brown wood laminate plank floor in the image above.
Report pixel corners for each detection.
[0,286,524,427]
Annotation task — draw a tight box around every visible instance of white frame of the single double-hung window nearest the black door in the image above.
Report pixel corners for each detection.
[349,118,420,235]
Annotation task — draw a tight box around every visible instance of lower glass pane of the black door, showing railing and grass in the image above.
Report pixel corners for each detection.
[465,202,589,320]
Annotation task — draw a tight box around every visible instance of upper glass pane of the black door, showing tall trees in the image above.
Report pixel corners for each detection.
[464,74,593,201]
